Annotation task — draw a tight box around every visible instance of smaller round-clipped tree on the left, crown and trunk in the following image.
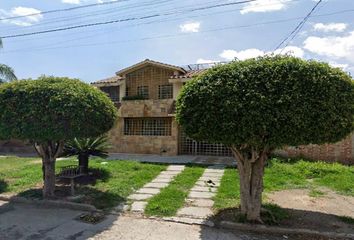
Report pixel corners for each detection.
[0,76,117,198]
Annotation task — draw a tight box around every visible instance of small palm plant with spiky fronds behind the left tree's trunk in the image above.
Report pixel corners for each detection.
[62,136,111,174]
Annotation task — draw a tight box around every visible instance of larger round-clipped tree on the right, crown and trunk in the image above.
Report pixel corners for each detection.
[176,56,354,222]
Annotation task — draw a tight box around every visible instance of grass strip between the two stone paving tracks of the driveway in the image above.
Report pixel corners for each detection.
[145,167,204,216]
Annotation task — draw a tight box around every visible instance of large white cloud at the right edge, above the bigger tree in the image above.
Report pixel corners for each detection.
[304,31,354,62]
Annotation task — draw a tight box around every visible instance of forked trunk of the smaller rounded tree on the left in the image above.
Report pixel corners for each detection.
[35,141,64,199]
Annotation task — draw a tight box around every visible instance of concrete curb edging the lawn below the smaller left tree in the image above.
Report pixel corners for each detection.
[0,195,98,212]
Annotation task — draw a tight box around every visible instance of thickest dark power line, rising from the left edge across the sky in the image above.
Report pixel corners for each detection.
[0,0,258,39]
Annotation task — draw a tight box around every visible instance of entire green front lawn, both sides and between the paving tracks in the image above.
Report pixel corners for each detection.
[0,157,354,216]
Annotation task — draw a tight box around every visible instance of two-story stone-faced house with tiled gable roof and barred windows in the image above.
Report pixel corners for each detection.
[92,59,231,156]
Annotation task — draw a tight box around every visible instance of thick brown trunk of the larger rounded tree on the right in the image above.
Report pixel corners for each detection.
[231,147,269,223]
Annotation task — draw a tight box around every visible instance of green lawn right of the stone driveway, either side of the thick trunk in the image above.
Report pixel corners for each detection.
[214,158,354,210]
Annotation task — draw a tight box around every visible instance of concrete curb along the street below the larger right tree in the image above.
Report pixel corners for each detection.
[218,221,354,239]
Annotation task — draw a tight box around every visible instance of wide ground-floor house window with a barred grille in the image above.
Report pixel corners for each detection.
[124,118,172,136]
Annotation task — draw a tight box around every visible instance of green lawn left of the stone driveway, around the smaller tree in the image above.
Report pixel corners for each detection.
[0,157,166,209]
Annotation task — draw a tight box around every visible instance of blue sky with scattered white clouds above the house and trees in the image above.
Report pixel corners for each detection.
[0,0,354,82]
